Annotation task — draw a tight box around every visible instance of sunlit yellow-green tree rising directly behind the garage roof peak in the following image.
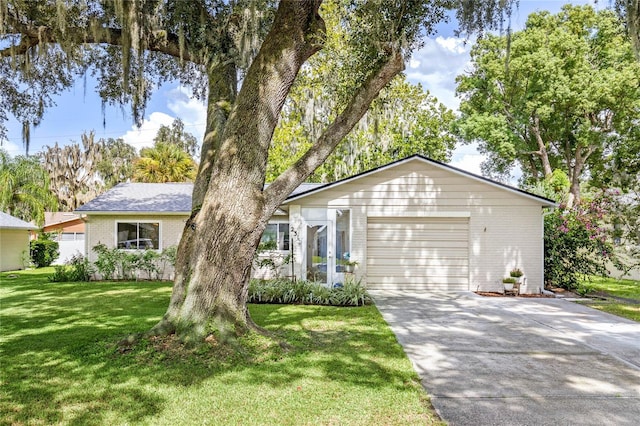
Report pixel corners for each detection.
[267,76,455,182]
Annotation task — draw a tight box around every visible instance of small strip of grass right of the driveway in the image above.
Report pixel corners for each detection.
[580,277,640,322]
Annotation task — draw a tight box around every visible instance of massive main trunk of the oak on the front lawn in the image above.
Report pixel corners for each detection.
[151,1,324,341]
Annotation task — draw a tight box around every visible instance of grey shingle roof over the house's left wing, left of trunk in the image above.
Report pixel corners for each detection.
[76,183,193,213]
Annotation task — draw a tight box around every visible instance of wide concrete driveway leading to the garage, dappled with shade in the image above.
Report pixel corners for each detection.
[373,292,640,426]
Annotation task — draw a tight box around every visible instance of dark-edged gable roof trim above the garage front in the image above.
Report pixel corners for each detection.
[284,154,558,207]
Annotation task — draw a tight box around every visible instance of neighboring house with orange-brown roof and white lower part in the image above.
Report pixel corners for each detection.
[42,212,85,265]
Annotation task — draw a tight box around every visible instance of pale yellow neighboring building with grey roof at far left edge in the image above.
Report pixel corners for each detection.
[0,212,38,271]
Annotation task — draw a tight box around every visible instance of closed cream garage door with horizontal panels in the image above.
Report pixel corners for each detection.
[367,217,469,291]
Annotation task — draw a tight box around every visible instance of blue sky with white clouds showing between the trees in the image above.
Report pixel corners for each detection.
[2,0,596,173]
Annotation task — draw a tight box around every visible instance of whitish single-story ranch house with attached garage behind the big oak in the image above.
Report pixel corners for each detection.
[76,155,556,293]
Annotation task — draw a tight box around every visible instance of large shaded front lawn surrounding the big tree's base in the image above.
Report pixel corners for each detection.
[0,269,441,425]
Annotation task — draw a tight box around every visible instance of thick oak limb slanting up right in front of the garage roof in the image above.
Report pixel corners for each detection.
[265,50,404,211]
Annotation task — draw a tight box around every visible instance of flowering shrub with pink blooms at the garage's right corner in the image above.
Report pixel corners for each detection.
[544,192,619,290]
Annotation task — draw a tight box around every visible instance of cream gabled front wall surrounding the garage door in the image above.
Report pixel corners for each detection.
[290,160,543,293]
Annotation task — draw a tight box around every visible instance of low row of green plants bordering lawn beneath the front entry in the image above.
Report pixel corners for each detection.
[248,279,371,306]
